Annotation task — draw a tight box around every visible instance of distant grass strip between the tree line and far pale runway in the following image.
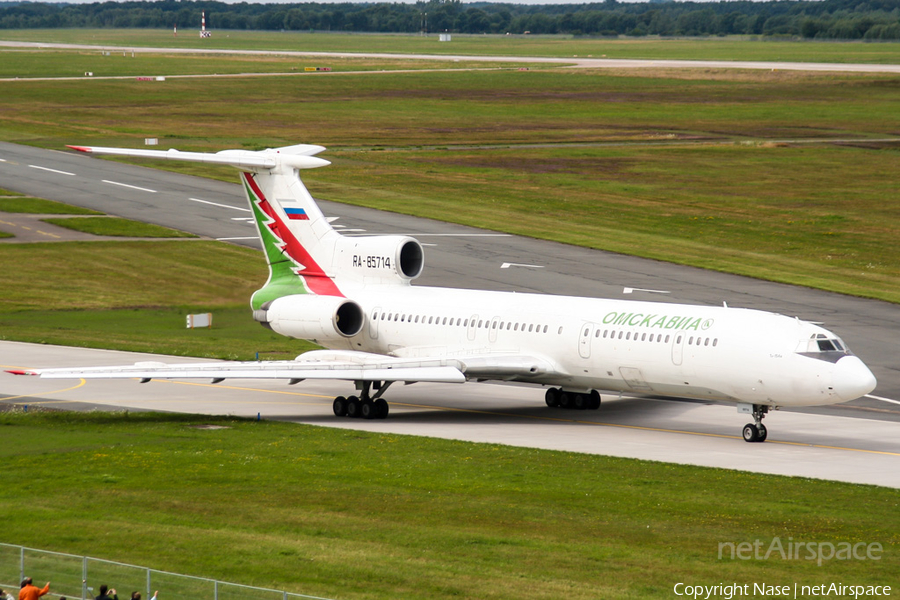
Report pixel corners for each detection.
[0,29,900,64]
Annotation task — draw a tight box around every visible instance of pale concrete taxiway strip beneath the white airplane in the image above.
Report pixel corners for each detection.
[0,342,900,488]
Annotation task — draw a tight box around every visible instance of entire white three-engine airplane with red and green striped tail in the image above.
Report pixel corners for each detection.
[7,145,875,442]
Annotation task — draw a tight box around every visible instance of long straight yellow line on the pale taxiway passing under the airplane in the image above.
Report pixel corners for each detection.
[137,380,900,456]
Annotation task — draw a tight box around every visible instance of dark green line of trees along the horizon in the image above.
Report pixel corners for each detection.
[0,0,900,40]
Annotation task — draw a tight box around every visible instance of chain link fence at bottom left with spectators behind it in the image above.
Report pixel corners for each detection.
[0,544,329,600]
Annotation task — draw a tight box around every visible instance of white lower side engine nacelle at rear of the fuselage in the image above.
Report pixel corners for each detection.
[253,294,365,343]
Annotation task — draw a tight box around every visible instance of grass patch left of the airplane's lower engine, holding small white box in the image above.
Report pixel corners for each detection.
[0,241,316,360]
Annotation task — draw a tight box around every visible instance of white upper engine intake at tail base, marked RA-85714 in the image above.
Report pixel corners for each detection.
[332,235,425,283]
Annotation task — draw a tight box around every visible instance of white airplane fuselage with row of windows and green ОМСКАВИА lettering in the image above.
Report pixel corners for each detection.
[272,286,872,406]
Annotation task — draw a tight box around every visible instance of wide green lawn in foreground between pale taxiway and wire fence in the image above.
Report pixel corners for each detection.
[0,411,900,599]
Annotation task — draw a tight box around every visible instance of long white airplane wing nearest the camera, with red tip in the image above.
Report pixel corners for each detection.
[8,350,549,383]
